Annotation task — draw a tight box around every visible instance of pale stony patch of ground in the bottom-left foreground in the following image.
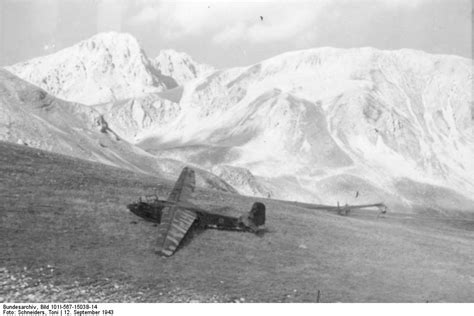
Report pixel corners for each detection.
[0,265,248,303]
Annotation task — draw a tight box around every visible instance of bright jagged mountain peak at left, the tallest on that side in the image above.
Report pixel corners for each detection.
[7,32,165,105]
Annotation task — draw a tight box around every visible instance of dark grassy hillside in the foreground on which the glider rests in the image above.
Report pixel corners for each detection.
[0,142,474,302]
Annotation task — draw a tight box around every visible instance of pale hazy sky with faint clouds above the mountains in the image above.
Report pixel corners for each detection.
[0,0,473,67]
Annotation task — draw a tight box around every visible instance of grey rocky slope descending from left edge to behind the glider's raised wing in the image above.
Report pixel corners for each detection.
[0,69,236,192]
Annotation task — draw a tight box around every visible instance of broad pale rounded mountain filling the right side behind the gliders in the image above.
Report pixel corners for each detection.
[137,48,474,209]
